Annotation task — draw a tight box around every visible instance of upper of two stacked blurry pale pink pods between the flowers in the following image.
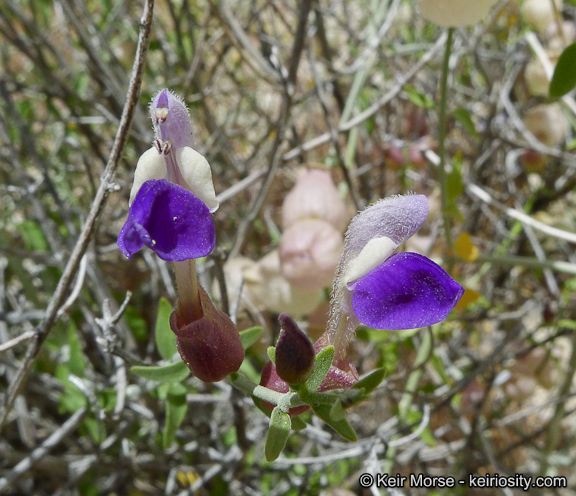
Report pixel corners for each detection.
[282,169,350,232]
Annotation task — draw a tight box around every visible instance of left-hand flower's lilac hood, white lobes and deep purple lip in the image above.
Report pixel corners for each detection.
[118,89,218,262]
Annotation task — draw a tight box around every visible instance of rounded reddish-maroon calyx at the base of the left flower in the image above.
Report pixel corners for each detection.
[170,286,244,382]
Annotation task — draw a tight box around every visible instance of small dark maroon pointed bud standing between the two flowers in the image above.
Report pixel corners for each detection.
[276,313,316,384]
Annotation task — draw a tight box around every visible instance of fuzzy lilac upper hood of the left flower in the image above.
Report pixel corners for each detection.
[150,88,194,148]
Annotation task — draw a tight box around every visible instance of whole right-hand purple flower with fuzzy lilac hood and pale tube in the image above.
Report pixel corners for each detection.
[327,195,464,358]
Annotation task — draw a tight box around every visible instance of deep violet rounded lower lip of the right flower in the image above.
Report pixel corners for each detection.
[352,253,464,331]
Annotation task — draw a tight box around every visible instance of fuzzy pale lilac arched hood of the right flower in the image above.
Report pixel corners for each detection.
[344,195,429,260]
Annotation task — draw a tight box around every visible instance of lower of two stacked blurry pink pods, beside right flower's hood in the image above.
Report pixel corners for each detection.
[278,219,344,290]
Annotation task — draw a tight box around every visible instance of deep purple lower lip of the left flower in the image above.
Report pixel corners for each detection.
[118,179,216,262]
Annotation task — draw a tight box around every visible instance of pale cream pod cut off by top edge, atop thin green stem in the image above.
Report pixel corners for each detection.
[417,0,497,27]
